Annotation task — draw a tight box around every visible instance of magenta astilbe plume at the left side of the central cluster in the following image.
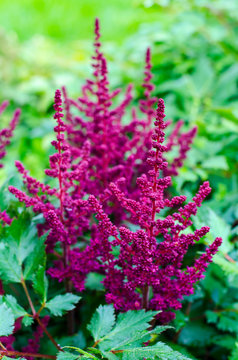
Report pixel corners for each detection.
[9,90,91,290]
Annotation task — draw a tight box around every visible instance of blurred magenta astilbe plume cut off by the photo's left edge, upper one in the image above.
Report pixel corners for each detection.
[0,101,21,168]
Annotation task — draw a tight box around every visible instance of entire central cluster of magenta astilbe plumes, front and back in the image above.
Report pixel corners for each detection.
[6,20,221,321]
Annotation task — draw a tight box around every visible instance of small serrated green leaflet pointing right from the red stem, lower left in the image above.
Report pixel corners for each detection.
[45,293,81,316]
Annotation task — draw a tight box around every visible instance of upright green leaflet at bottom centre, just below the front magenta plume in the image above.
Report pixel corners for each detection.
[87,305,115,341]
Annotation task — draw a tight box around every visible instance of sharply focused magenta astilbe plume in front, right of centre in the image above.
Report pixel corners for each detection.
[88,99,222,322]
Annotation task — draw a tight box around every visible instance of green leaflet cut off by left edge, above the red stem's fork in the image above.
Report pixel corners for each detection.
[0,243,21,283]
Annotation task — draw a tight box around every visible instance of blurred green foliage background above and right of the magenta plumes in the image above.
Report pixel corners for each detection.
[0,0,238,360]
